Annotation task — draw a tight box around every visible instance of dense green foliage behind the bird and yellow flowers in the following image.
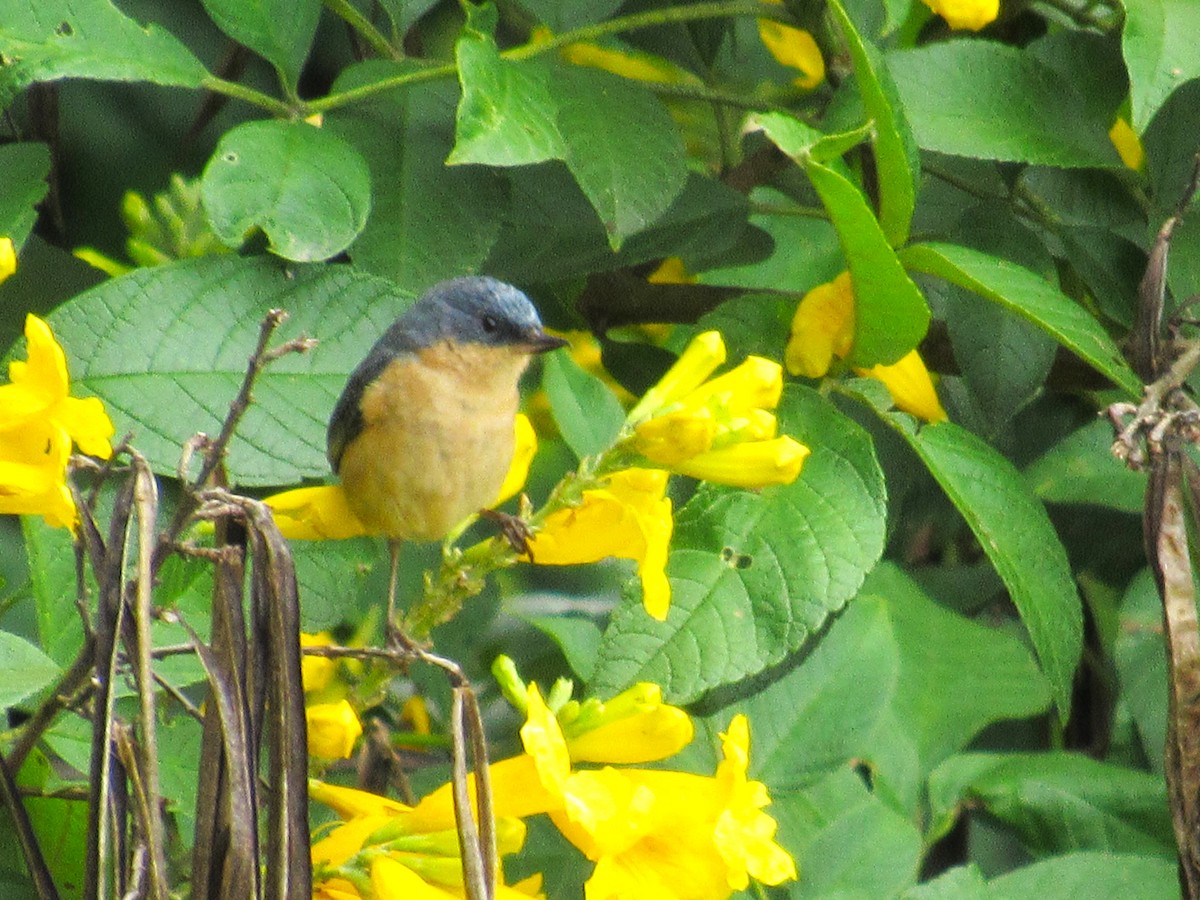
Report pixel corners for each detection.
[0,0,1200,900]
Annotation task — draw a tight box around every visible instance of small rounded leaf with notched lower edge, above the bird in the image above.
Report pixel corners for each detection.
[200,121,371,263]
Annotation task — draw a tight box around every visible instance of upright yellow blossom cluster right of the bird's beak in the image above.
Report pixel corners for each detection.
[623,331,809,487]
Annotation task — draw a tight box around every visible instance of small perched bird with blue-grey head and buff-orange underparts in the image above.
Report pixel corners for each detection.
[326,276,568,637]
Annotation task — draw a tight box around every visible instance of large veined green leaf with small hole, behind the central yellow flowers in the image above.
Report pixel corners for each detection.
[593,385,884,702]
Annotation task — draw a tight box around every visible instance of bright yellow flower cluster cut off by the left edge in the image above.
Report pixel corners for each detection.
[0,285,114,530]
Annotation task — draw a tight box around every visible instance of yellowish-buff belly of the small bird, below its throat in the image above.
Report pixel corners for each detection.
[340,391,516,541]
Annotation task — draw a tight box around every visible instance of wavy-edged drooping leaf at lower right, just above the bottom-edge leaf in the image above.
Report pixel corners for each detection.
[929,752,1175,856]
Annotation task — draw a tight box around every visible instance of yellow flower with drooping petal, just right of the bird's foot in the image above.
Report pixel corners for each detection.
[529,469,674,620]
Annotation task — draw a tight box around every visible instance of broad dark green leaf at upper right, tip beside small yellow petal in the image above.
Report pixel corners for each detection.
[887,41,1122,168]
